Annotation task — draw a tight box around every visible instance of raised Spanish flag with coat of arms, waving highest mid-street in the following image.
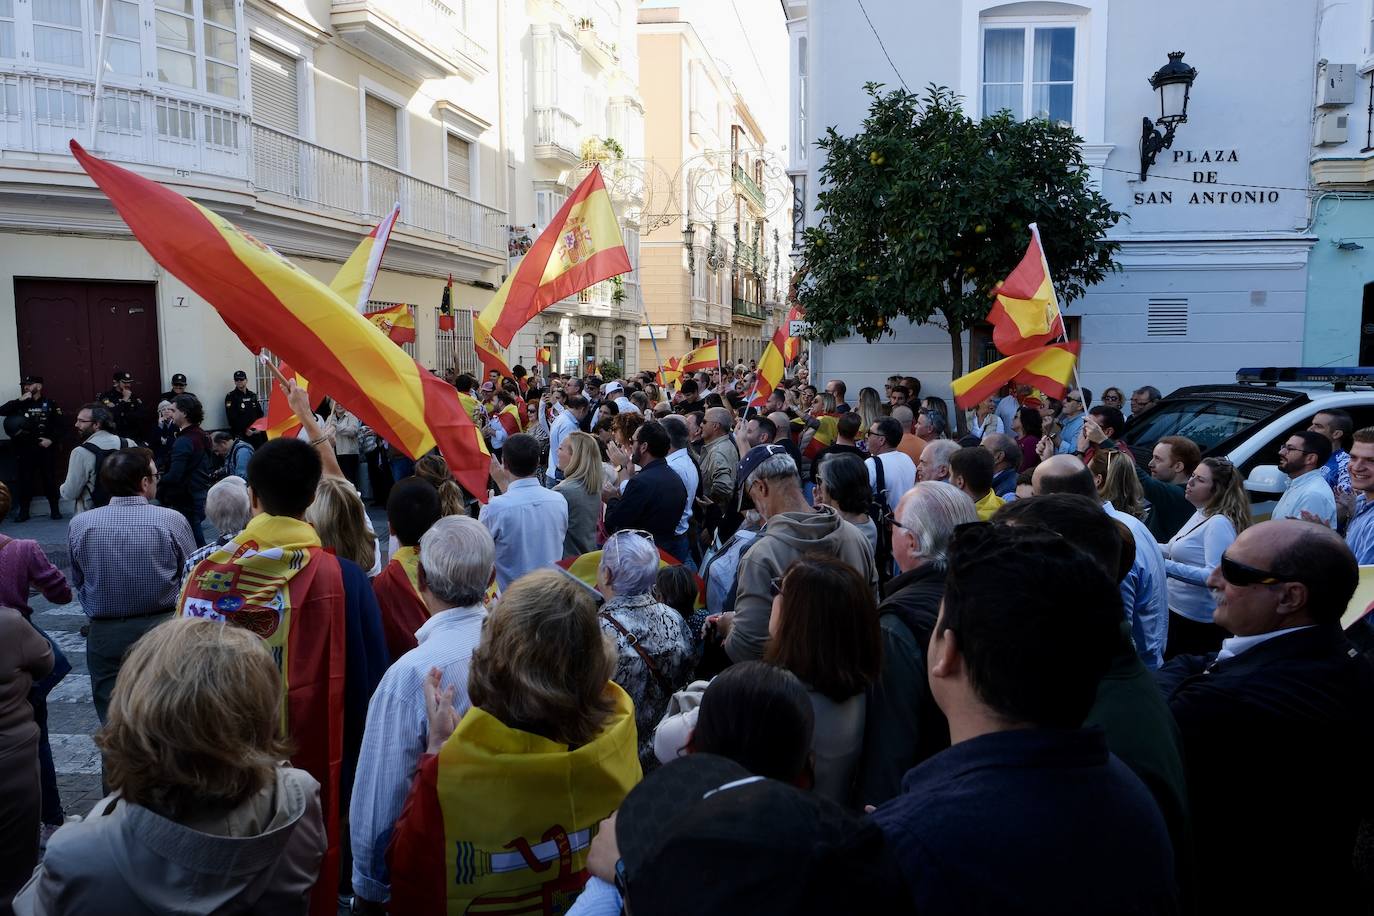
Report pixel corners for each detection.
[482,166,631,346]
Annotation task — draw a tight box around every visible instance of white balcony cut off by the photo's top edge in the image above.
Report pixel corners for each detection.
[330,0,486,80]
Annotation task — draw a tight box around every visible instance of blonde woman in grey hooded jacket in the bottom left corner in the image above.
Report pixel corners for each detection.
[15,617,326,915]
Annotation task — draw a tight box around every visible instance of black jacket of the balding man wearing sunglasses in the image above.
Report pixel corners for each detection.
[1156,623,1374,913]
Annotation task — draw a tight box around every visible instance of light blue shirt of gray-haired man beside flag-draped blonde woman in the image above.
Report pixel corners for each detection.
[349,601,489,902]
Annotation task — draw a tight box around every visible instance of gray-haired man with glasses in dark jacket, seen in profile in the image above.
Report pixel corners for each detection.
[857,483,978,805]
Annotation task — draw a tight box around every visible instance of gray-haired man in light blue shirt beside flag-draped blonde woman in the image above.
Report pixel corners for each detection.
[349,515,496,912]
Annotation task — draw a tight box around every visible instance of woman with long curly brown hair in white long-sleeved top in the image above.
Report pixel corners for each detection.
[1164,457,1250,659]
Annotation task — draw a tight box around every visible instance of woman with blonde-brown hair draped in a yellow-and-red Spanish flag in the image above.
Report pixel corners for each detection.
[387,570,640,916]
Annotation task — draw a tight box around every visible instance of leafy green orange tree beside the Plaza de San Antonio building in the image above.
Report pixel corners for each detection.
[798,82,1123,387]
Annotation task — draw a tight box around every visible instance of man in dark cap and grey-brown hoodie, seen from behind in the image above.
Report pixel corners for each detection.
[710,445,878,662]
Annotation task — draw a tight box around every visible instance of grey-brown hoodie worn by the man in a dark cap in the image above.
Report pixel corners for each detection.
[725,507,878,662]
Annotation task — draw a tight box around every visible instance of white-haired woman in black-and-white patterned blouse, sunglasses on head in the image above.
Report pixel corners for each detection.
[596,530,695,770]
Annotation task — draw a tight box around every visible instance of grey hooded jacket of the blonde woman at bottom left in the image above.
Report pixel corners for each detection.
[14,766,326,916]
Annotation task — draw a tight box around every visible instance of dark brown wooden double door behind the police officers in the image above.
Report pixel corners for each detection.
[10,277,162,450]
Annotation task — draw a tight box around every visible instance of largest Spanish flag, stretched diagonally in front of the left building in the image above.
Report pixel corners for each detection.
[71,140,491,501]
